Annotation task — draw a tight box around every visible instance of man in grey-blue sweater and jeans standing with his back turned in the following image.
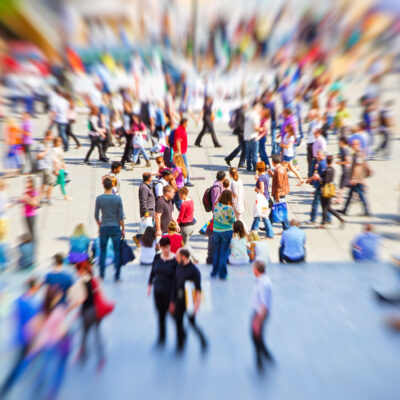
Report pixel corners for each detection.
[94,178,125,282]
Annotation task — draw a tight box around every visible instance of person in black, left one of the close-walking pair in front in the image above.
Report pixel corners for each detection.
[147,236,178,346]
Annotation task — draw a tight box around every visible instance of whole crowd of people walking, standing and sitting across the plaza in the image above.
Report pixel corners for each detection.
[0,56,395,394]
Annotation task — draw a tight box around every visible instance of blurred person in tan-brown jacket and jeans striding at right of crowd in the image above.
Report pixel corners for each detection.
[338,140,370,217]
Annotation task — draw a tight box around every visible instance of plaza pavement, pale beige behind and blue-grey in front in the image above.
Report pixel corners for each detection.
[0,74,400,399]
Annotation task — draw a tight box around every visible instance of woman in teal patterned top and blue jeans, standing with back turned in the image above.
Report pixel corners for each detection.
[211,190,235,279]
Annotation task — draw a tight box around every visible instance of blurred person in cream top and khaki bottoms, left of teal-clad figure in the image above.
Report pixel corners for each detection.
[37,130,54,205]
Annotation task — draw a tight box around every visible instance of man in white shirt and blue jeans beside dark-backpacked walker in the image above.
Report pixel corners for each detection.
[243,103,261,171]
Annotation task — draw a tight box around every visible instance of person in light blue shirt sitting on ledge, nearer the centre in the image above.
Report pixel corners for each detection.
[279,219,306,263]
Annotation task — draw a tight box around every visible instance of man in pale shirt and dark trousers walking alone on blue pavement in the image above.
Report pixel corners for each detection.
[251,260,274,372]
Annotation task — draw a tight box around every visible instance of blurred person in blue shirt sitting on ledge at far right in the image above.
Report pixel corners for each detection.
[351,224,382,261]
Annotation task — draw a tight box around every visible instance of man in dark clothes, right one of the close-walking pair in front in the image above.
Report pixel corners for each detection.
[169,248,207,352]
